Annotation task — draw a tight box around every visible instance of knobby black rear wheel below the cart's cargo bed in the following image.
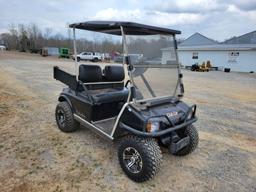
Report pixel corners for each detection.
[55,101,79,133]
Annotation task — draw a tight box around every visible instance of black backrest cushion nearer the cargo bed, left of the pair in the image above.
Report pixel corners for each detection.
[78,65,102,83]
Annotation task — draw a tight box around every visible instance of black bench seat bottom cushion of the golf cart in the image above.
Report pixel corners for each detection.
[89,87,129,104]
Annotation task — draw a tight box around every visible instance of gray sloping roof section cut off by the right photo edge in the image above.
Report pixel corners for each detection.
[223,31,256,44]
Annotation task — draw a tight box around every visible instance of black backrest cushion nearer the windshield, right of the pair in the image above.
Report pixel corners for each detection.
[104,65,124,81]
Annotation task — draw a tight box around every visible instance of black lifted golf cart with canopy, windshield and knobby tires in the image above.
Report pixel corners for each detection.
[54,21,198,182]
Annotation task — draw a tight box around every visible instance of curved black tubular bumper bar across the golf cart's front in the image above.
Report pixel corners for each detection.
[119,117,197,137]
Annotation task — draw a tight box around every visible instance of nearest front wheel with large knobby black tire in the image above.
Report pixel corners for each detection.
[118,136,162,182]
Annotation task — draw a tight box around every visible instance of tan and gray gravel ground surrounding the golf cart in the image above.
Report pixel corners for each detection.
[0,52,256,192]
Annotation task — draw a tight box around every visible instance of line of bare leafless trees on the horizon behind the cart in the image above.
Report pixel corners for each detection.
[0,24,182,57]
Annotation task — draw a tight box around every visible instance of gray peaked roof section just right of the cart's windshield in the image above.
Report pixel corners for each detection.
[179,33,218,47]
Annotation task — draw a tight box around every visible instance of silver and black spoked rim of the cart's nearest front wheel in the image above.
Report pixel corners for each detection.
[123,147,143,173]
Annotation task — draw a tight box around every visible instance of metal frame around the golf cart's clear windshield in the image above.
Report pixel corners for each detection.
[120,26,184,103]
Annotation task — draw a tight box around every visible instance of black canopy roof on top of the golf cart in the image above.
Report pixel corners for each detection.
[69,21,181,35]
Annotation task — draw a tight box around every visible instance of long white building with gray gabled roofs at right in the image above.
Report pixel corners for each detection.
[176,31,256,72]
